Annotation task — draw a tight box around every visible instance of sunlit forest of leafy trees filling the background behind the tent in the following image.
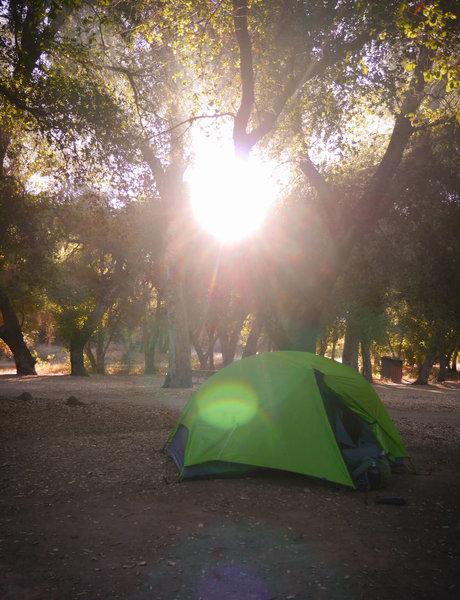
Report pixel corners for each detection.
[0,0,460,387]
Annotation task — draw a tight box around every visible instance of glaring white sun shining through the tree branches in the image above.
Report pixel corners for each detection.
[185,146,278,244]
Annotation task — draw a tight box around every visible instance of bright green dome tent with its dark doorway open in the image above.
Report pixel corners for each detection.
[167,351,408,487]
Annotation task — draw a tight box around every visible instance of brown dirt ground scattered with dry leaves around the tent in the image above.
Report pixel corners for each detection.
[0,375,460,600]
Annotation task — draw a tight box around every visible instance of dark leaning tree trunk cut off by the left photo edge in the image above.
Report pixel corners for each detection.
[0,291,37,375]
